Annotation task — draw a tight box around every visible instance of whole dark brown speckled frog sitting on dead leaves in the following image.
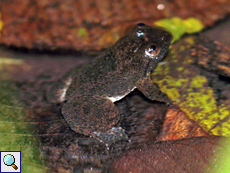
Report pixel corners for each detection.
[47,23,172,146]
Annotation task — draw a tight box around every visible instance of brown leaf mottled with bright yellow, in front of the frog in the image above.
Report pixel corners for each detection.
[152,37,230,137]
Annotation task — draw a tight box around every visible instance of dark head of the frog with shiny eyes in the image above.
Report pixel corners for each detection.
[115,23,172,75]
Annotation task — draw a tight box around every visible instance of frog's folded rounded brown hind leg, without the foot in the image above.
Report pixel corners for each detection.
[62,94,120,136]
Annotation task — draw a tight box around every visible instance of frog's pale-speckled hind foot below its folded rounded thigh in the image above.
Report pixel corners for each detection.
[93,127,131,150]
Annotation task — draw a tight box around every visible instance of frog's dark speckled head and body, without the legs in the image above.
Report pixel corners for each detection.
[47,24,172,102]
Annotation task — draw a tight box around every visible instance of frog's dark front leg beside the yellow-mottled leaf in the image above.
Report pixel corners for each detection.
[137,76,171,103]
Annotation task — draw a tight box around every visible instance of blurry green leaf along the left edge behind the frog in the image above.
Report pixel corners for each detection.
[0,58,47,172]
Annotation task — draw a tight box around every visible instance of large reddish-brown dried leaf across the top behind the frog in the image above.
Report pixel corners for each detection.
[0,0,230,50]
